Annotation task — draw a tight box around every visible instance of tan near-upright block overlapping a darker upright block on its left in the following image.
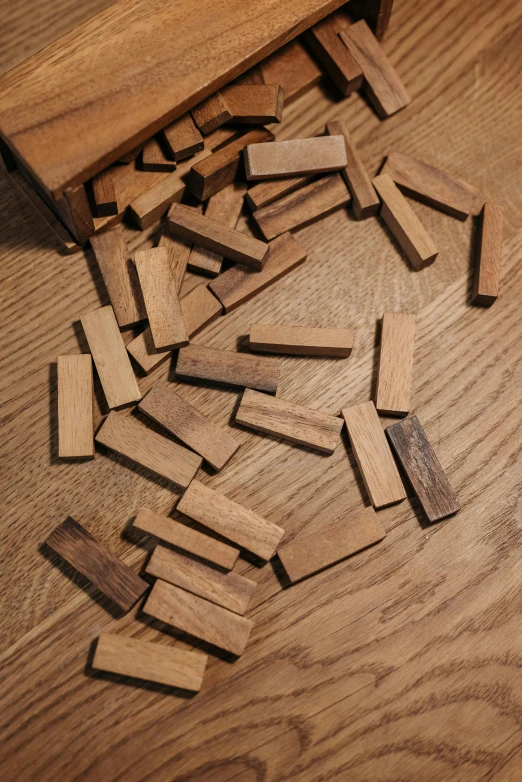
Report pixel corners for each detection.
[134,247,188,349]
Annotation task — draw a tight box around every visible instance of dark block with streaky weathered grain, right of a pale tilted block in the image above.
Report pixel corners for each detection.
[386,415,460,522]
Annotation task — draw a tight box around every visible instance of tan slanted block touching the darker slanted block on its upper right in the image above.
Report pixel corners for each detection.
[96,413,203,488]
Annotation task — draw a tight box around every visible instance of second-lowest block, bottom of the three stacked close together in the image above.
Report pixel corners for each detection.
[143,581,254,656]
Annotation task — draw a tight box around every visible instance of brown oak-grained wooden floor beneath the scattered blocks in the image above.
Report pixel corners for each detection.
[0,0,522,782]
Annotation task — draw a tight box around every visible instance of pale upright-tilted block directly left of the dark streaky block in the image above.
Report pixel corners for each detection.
[341,402,406,508]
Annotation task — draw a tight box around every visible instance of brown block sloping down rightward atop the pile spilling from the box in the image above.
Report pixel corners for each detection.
[169,204,268,271]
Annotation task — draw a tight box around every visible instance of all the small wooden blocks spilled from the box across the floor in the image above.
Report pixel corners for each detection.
[46,15,502,690]
